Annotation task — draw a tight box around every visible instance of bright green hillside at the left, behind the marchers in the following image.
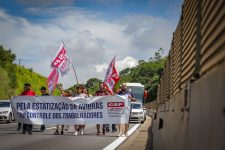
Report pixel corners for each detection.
[0,46,60,99]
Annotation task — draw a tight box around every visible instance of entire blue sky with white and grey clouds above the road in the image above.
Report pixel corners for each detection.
[0,0,183,88]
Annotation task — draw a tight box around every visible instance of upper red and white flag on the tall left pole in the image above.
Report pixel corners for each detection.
[51,43,71,76]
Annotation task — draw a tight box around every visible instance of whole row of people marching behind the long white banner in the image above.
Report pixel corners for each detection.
[17,82,135,136]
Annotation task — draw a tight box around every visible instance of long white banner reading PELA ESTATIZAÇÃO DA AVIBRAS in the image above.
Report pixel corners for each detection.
[11,95,131,125]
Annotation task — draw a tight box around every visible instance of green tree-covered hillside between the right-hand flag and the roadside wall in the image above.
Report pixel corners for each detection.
[116,48,167,102]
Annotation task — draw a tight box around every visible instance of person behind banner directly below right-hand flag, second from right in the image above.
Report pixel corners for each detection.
[95,82,109,135]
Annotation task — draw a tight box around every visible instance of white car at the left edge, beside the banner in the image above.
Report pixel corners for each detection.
[0,100,15,123]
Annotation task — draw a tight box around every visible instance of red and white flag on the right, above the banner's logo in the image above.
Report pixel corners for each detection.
[104,57,120,94]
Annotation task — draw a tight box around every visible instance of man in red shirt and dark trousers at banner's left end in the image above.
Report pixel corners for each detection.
[17,83,36,134]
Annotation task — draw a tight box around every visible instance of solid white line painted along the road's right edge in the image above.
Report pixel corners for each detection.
[103,124,140,150]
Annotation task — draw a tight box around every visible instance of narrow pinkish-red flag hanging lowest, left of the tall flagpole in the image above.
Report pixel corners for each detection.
[48,68,59,94]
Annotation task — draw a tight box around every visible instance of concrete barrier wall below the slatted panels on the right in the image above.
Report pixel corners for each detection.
[151,61,225,150]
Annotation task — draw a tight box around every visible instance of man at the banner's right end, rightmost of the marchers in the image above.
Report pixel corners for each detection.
[117,83,136,136]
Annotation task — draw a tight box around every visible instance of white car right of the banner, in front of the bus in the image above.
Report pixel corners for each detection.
[130,102,145,123]
